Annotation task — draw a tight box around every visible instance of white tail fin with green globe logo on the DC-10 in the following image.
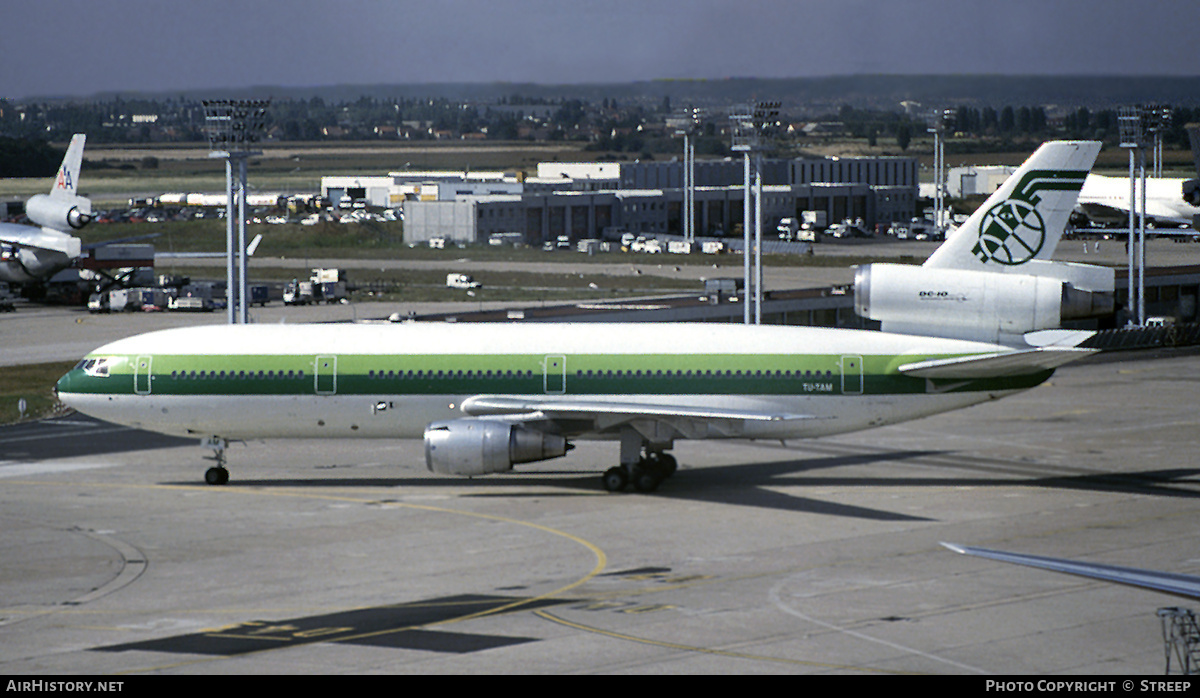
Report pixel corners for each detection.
[924,140,1100,272]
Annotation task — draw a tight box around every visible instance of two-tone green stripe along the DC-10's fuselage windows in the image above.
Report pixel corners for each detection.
[59,354,1052,396]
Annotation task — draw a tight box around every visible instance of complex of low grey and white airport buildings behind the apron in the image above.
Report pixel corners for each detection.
[322,157,918,245]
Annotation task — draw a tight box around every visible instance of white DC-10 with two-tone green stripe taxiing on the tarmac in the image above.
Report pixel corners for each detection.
[58,142,1112,492]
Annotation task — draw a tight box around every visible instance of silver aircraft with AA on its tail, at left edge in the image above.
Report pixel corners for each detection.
[0,133,91,283]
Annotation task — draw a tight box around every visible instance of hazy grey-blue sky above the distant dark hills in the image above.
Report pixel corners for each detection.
[9,0,1200,98]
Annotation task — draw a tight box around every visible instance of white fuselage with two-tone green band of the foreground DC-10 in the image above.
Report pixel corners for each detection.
[59,324,1040,439]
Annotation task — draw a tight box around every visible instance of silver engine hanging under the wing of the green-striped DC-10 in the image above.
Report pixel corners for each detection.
[425,419,570,475]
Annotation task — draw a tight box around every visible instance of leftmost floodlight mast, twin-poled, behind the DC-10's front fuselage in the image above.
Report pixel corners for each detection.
[203,100,271,325]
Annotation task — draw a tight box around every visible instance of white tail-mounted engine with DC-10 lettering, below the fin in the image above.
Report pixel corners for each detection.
[854,264,1112,343]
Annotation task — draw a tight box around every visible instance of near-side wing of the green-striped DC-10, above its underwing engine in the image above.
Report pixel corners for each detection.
[462,396,816,422]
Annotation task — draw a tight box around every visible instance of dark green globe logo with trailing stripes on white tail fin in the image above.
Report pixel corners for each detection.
[971,170,1087,265]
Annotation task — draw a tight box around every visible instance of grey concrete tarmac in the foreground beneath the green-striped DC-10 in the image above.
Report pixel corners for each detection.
[0,351,1200,687]
